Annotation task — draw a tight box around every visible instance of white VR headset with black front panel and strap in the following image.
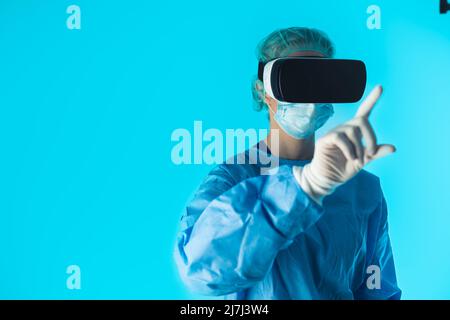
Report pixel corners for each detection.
[258,57,367,103]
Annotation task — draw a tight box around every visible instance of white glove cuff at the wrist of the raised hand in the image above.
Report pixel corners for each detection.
[292,164,337,205]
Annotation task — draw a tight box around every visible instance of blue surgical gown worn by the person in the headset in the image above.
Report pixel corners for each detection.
[175,144,401,299]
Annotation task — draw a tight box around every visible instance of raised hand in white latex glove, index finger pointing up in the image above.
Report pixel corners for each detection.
[293,86,395,204]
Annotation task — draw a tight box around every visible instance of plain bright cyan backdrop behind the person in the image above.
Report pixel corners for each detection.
[0,0,450,299]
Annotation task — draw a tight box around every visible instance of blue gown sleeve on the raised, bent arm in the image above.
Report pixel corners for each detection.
[175,165,323,295]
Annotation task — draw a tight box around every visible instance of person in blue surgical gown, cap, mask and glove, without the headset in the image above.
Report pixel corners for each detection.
[175,28,401,299]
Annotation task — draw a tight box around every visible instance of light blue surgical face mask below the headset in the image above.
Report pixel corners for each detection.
[272,102,334,139]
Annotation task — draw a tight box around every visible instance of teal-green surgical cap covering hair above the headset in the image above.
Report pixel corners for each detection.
[252,27,334,111]
